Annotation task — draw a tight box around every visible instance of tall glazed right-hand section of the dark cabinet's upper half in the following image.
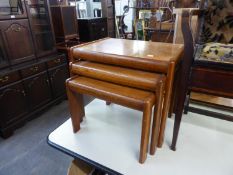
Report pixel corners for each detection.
[27,0,56,57]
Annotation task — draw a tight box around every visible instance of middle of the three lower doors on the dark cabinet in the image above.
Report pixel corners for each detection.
[24,72,51,110]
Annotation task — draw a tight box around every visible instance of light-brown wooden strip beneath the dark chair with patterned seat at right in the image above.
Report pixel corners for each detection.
[191,92,233,108]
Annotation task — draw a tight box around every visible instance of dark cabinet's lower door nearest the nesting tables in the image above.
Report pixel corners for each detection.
[49,64,69,98]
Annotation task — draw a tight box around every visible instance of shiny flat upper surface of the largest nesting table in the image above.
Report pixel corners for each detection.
[75,38,183,62]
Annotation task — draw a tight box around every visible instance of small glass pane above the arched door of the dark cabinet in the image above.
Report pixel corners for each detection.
[0,0,24,15]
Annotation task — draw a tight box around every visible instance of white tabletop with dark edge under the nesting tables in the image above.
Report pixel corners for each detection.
[48,100,233,175]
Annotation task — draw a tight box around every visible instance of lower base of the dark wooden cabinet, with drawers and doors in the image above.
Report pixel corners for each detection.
[0,55,69,137]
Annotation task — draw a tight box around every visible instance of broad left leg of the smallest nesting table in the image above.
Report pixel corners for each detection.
[66,82,85,133]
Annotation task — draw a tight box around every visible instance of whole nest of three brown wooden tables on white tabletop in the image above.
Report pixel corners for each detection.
[67,38,183,163]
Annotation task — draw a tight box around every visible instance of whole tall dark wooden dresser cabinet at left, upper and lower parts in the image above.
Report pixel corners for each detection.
[0,0,68,138]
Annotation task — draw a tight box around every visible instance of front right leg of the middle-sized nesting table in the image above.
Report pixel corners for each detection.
[150,82,163,155]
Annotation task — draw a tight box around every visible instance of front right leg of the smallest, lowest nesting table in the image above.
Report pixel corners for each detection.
[139,103,152,163]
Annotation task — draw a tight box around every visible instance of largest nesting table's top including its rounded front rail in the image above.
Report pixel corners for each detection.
[72,38,183,73]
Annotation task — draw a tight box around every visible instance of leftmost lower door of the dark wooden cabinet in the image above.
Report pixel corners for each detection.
[0,83,28,128]
